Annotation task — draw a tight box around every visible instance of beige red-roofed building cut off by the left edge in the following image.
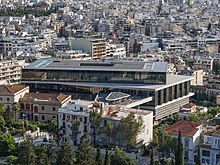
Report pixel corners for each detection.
[0,85,29,107]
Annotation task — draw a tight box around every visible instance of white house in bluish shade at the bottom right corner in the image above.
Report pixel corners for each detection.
[200,130,220,165]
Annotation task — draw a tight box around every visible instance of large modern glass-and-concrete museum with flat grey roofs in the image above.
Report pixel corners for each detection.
[22,60,193,120]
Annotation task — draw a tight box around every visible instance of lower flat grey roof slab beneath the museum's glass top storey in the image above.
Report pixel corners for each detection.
[22,74,194,91]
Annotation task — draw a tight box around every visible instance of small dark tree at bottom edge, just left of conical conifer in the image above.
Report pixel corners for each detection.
[35,146,51,165]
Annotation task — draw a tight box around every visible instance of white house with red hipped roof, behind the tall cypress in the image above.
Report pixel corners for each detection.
[163,120,203,165]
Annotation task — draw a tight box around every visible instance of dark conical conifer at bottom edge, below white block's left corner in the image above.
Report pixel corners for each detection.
[56,141,75,165]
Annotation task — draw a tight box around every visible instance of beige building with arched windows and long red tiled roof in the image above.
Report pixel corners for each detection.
[19,93,71,122]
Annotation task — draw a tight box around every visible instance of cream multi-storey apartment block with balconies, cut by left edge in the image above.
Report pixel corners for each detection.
[0,60,25,85]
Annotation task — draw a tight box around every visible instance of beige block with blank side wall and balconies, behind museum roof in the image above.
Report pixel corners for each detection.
[69,38,106,59]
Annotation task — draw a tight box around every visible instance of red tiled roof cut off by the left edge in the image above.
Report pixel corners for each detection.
[0,85,26,94]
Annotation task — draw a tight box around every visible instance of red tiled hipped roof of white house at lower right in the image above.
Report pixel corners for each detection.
[163,121,201,136]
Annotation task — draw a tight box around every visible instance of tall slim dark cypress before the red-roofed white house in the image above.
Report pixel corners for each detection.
[175,131,184,165]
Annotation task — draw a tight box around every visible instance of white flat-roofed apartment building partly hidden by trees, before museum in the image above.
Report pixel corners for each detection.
[58,100,153,146]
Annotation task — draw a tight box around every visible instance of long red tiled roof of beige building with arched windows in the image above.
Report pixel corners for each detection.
[19,93,70,103]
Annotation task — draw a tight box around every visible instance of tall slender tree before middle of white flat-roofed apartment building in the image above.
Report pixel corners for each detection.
[89,109,102,147]
